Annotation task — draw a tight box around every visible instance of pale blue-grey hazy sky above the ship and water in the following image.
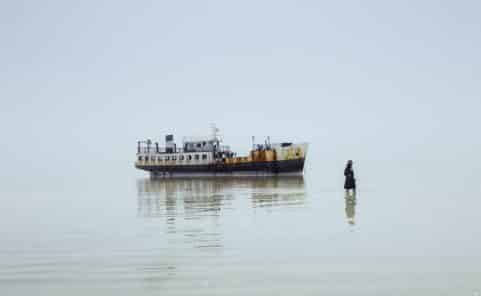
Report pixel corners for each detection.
[0,1,481,184]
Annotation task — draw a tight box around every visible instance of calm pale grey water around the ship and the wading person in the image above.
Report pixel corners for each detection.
[0,162,481,295]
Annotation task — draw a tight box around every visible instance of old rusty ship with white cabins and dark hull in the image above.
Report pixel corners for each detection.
[135,126,308,178]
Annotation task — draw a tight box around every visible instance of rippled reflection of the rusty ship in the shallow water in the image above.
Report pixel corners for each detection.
[137,176,305,249]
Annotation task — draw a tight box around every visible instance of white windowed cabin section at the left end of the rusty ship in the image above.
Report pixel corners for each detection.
[137,135,233,166]
